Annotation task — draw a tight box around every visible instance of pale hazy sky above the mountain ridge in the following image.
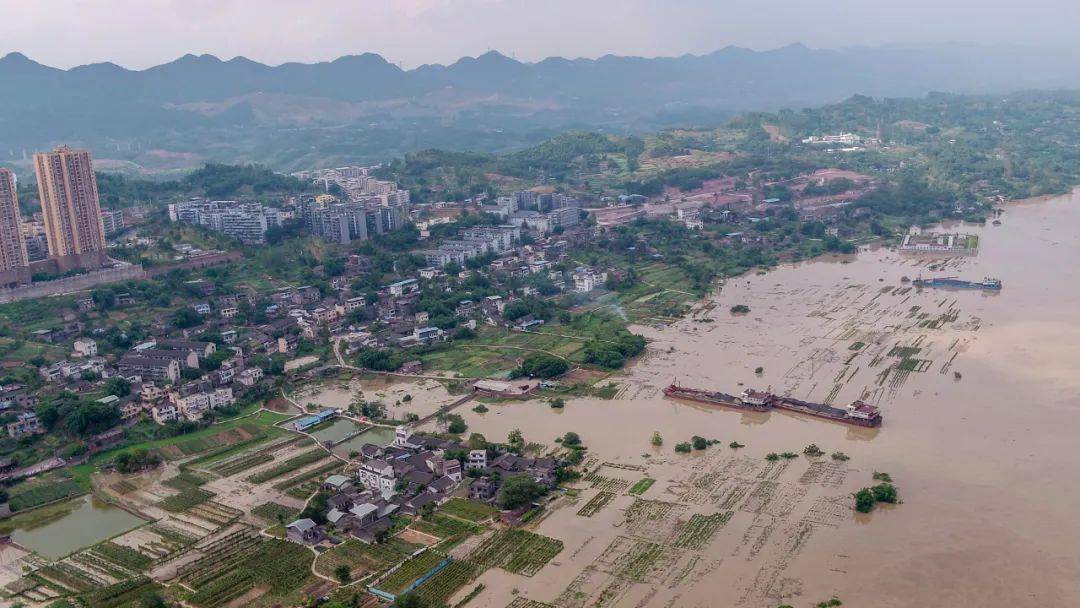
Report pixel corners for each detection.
[0,0,1080,68]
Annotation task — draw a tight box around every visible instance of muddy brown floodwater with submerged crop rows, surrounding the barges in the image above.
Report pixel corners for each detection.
[434,193,1080,608]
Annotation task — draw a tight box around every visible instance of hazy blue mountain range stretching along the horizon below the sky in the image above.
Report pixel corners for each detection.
[0,44,1080,168]
